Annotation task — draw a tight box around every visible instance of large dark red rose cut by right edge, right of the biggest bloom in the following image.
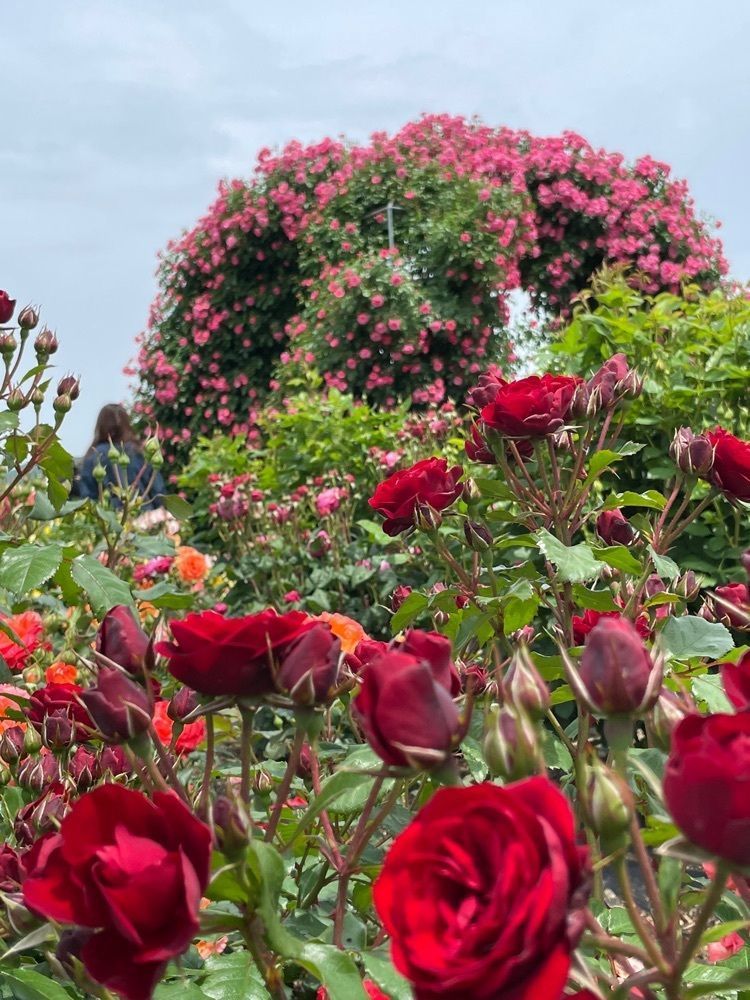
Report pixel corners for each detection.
[664,712,750,865]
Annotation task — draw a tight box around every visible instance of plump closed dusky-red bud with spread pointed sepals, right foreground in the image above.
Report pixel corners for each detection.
[565,618,663,716]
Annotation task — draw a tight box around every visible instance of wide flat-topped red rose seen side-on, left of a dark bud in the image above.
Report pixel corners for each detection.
[156,608,314,696]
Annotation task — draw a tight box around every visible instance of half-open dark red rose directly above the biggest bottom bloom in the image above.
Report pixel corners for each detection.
[353,650,460,767]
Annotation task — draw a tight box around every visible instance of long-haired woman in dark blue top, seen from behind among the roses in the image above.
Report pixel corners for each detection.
[79,403,165,510]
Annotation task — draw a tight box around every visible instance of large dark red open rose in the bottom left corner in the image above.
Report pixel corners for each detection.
[23,784,211,1000]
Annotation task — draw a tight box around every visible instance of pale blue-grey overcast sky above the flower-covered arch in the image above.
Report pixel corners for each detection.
[0,0,750,452]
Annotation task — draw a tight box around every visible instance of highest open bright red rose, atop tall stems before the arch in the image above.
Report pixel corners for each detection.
[482,375,581,438]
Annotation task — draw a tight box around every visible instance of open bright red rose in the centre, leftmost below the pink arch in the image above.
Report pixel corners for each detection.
[368,458,463,535]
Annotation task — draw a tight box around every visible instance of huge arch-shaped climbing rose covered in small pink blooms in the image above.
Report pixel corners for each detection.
[135,116,725,458]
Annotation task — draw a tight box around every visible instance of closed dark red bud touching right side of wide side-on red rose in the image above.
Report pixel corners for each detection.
[276,622,341,705]
